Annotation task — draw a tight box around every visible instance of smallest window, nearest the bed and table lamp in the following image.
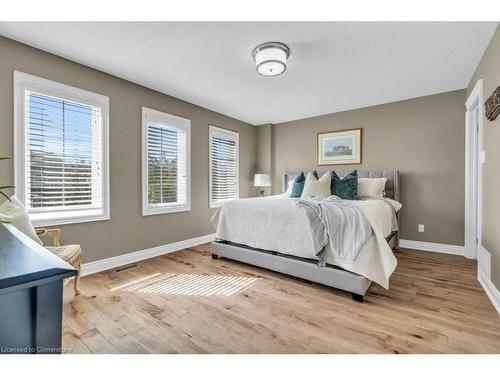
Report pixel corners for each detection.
[209,126,239,208]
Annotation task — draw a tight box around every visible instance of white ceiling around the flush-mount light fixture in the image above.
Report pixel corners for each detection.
[0,22,497,125]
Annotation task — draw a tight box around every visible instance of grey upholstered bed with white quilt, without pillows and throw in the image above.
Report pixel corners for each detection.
[211,170,400,302]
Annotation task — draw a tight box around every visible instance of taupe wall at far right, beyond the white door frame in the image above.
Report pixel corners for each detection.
[467,28,500,289]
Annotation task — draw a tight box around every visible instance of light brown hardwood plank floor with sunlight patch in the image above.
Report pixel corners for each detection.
[63,244,500,353]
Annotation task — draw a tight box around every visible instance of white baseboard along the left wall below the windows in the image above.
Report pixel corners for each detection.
[82,233,215,276]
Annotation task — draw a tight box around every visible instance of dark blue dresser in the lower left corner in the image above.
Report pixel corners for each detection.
[0,223,76,354]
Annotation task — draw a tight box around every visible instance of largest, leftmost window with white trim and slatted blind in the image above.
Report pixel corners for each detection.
[14,72,109,226]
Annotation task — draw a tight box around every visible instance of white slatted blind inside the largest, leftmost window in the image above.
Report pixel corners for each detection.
[26,91,102,212]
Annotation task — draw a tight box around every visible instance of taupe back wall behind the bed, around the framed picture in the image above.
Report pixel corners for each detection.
[271,90,465,245]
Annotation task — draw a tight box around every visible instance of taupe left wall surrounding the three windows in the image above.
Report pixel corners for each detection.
[0,37,257,262]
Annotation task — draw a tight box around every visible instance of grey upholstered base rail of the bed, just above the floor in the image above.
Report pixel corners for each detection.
[210,241,371,302]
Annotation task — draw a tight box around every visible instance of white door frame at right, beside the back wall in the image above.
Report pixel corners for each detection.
[464,79,483,259]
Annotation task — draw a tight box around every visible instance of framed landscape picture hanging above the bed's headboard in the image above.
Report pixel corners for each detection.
[318,128,362,165]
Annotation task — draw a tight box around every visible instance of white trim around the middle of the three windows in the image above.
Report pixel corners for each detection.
[141,107,191,216]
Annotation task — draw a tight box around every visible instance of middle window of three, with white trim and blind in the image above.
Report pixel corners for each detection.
[142,107,191,215]
